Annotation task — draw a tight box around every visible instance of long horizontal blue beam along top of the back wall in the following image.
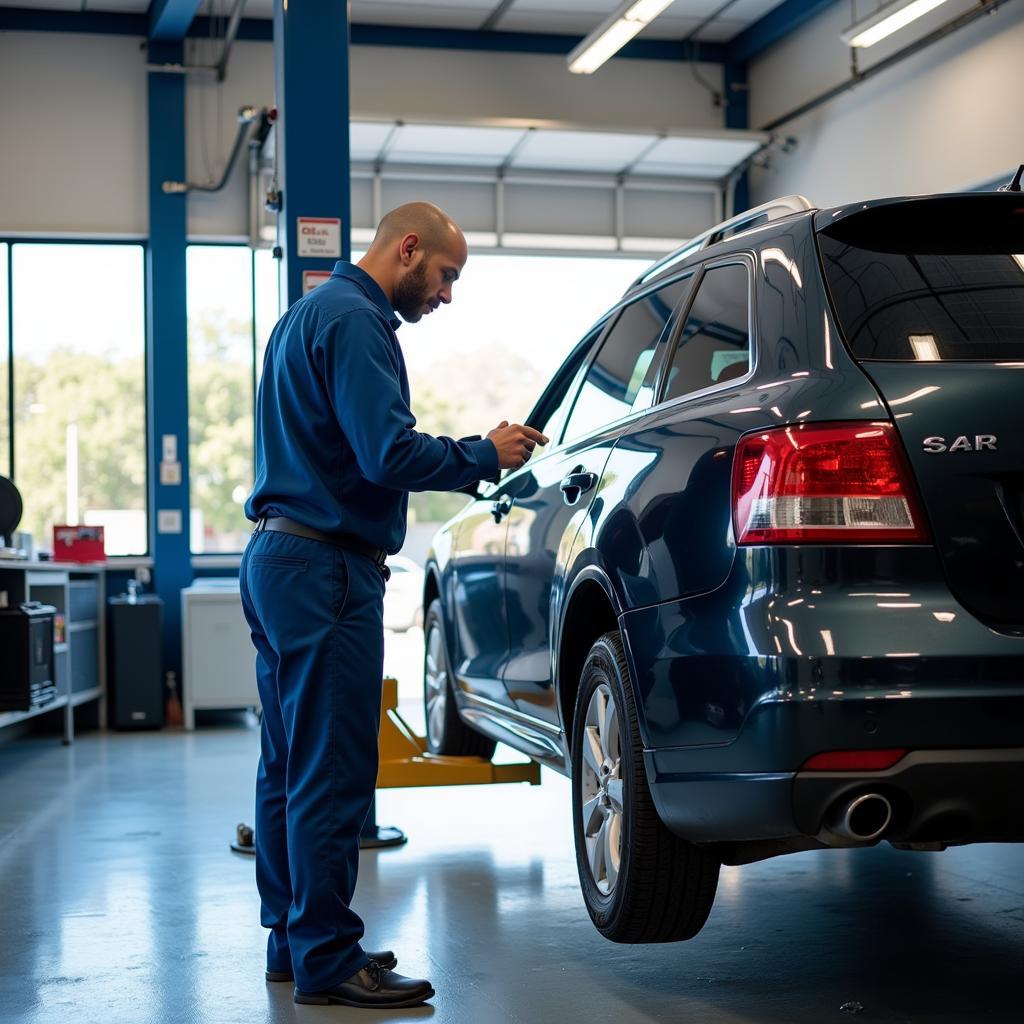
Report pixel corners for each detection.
[0,9,726,63]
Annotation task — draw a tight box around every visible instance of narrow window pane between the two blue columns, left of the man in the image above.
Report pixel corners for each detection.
[186,246,253,554]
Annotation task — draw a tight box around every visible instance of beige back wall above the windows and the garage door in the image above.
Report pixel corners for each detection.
[0,33,723,237]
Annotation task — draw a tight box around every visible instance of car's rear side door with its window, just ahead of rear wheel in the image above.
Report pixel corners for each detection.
[504,281,689,726]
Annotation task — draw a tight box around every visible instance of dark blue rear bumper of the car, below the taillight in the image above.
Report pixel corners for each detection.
[620,548,1024,842]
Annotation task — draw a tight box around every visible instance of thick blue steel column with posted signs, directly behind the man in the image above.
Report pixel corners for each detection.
[273,0,351,306]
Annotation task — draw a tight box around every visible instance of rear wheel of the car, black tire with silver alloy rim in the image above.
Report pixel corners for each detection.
[572,632,720,942]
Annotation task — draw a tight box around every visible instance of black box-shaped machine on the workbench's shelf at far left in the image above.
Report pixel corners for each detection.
[0,601,57,711]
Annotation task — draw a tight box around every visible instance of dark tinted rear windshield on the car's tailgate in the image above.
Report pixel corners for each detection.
[818,193,1024,361]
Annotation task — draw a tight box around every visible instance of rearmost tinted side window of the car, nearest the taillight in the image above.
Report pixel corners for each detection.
[665,263,751,400]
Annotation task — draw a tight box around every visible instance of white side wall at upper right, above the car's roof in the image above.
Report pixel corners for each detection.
[750,0,1024,206]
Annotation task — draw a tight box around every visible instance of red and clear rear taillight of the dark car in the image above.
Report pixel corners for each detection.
[732,422,928,544]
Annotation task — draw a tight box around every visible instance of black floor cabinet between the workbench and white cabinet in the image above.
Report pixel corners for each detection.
[106,594,164,729]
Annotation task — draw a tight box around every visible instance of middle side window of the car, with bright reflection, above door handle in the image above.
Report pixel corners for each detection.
[564,279,690,440]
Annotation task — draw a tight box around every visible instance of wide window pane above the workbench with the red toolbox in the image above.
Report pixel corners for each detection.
[10,243,146,555]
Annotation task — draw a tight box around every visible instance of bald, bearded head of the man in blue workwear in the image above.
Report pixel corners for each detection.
[359,203,469,324]
